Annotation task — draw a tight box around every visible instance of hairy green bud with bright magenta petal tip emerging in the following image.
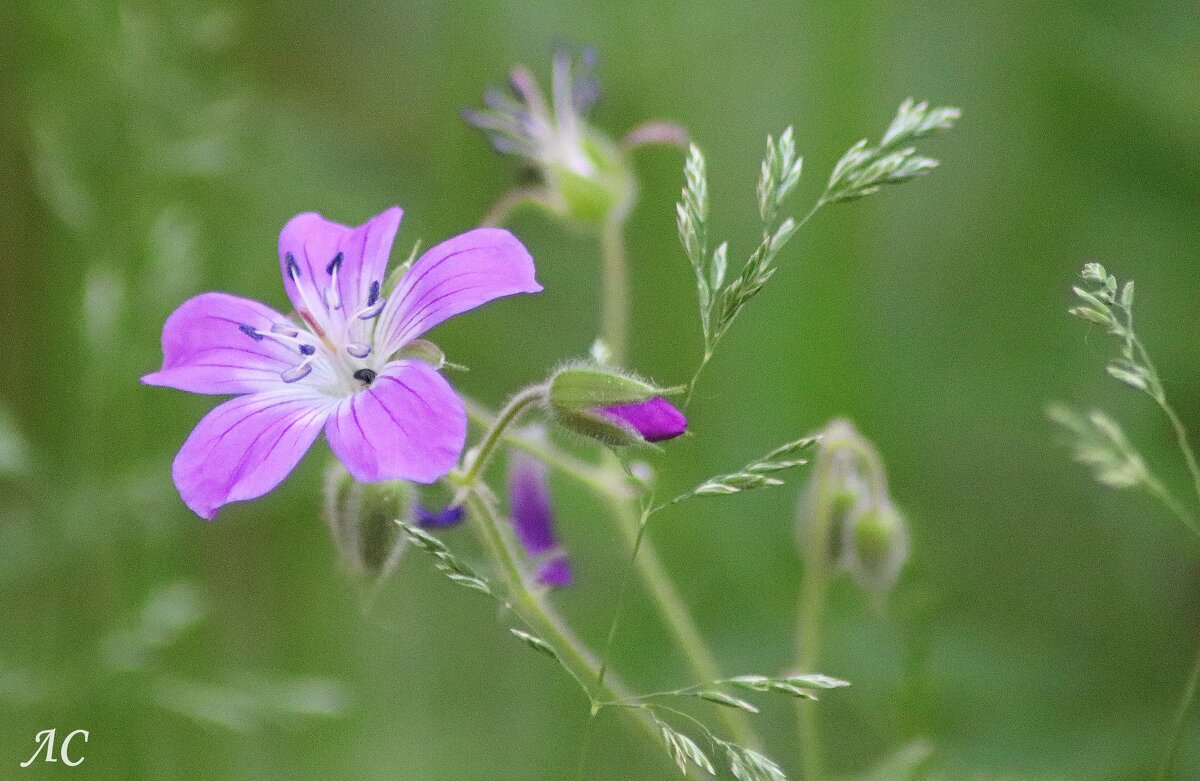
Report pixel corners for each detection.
[547,364,688,446]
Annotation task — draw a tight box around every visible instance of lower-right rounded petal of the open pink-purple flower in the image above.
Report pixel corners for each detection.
[325,360,467,482]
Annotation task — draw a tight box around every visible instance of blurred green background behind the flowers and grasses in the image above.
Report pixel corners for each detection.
[0,0,1200,781]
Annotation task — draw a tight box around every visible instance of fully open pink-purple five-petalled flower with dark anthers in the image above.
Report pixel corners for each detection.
[142,208,541,518]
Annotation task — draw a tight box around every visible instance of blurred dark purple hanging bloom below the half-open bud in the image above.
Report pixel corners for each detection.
[509,451,571,587]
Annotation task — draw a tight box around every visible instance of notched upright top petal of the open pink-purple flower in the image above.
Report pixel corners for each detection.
[280,206,403,329]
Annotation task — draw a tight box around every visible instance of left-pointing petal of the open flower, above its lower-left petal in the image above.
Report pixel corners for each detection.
[142,293,301,393]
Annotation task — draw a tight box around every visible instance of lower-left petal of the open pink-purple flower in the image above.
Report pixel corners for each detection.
[172,388,336,521]
